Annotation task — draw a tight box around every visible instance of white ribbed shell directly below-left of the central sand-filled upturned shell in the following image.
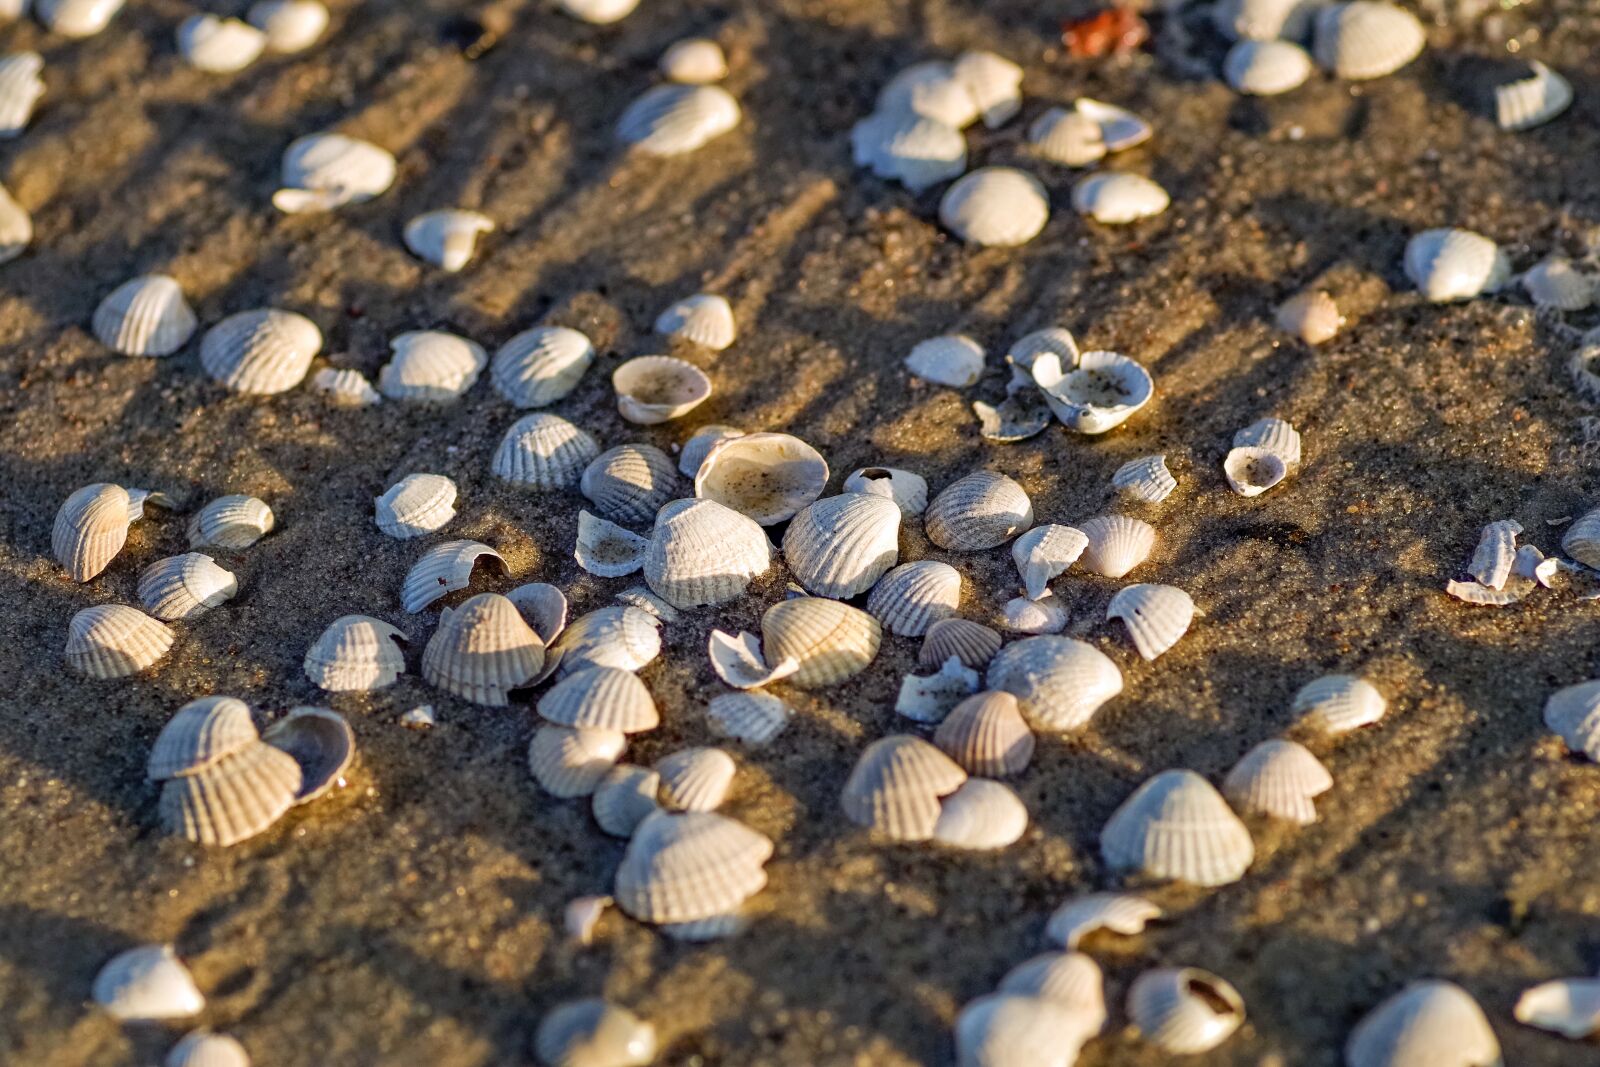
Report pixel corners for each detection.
[645,501,773,609]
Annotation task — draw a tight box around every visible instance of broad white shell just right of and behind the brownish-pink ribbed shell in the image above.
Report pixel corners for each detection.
[986,635,1122,731]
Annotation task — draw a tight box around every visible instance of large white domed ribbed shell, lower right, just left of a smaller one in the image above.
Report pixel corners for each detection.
[1101,771,1256,886]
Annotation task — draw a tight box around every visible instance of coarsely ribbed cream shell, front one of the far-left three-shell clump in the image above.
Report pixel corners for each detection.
[158,742,302,848]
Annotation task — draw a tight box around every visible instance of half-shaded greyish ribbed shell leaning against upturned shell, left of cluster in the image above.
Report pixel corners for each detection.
[422,593,544,707]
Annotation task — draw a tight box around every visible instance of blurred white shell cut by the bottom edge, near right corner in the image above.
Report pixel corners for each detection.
[1344,979,1501,1067]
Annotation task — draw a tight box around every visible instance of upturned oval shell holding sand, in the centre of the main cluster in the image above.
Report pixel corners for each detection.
[694,434,827,526]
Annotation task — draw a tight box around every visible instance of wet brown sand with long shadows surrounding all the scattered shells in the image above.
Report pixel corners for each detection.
[0,0,1600,1067]
